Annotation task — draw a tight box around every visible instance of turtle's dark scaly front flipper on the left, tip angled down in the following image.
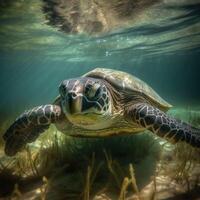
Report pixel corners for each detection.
[3,105,61,156]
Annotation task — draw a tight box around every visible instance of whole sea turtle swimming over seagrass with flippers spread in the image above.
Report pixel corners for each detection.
[3,68,200,156]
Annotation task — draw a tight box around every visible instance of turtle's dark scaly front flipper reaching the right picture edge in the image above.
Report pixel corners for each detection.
[126,104,200,148]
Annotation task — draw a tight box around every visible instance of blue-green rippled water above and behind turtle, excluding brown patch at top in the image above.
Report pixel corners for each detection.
[0,0,200,116]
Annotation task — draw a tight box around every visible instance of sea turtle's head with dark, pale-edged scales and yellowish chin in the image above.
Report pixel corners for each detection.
[59,77,112,130]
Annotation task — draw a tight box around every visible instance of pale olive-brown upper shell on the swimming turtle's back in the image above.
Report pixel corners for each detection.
[83,68,172,111]
